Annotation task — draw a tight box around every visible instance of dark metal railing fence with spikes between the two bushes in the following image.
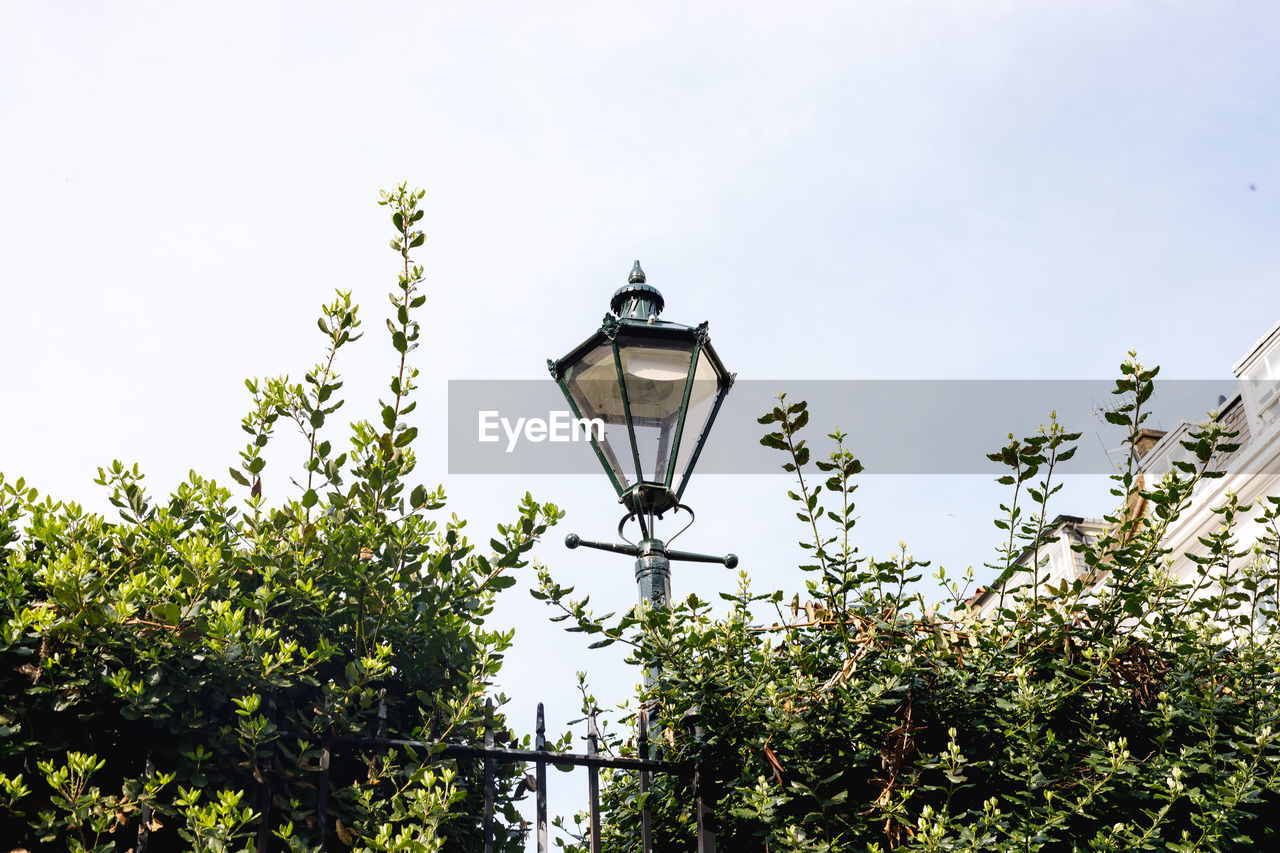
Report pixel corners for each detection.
[257,702,716,853]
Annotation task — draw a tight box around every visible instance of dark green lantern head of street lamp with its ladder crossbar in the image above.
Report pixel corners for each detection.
[547,261,737,607]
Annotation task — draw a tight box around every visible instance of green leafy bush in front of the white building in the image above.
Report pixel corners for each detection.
[536,361,1280,852]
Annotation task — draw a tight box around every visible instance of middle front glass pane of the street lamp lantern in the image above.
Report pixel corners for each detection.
[618,334,694,483]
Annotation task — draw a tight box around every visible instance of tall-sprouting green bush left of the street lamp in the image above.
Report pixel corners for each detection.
[0,184,559,853]
